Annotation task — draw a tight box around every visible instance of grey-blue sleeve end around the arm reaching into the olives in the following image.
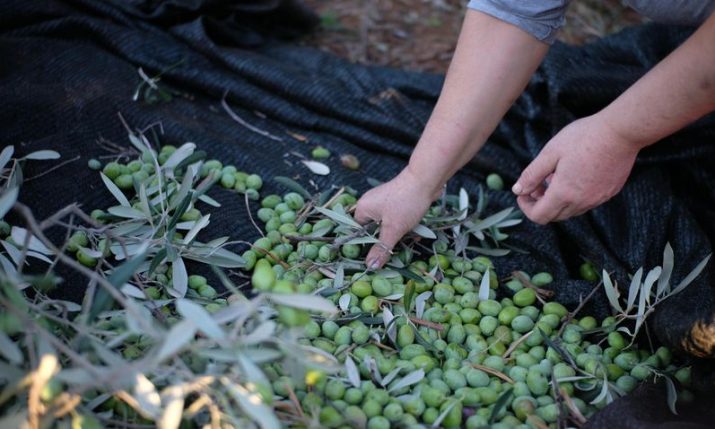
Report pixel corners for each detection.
[467,0,570,44]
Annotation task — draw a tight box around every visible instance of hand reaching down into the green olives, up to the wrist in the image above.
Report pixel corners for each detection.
[355,167,439,270]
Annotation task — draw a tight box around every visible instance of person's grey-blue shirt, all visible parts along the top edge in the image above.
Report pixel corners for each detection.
[468,0,715,43]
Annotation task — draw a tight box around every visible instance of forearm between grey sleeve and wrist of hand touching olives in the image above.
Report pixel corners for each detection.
[408,10,548,194]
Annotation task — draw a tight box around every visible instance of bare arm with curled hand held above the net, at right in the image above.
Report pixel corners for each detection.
[513,11,715,224]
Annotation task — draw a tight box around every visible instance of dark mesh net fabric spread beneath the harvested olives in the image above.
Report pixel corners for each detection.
[0,0,715,427]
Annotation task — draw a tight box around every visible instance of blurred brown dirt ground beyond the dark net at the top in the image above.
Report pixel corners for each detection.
[303,0,641,73]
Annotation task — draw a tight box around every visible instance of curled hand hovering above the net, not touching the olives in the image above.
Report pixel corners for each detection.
[512,115,642,225]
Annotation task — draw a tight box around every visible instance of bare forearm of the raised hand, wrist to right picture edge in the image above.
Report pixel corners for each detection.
[598,14,715,148]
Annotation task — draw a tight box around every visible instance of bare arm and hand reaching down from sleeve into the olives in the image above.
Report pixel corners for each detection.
[355,10,548,268]
